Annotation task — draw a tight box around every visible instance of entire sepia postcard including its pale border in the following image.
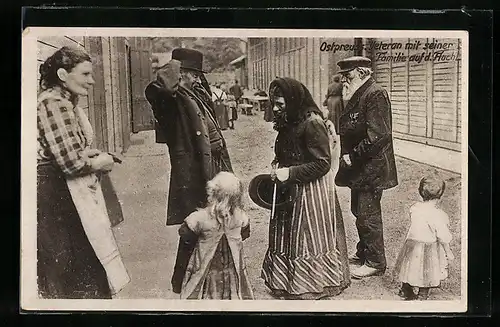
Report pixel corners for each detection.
[21,27,468,312]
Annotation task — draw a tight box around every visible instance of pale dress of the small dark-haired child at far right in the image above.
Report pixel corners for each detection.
[394,202,452,287]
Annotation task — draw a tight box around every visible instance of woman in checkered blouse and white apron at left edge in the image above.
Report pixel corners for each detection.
[37,47,130,299]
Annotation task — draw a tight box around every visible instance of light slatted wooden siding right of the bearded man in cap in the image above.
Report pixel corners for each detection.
[365,38,462,151]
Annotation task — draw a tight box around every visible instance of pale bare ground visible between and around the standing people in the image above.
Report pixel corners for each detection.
[111,113,461,300]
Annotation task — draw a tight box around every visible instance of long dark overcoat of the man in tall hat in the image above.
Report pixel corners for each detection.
[145,81,232,225]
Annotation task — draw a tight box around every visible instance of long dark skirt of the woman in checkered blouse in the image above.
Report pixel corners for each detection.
[37,165,111,299]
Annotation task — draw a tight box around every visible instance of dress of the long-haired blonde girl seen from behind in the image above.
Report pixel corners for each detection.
[179,209,254,300]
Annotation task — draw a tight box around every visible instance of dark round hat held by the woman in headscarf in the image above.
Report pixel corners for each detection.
[248,174,298,210]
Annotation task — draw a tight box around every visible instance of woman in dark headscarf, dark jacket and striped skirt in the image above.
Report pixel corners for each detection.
[262,78,350,299]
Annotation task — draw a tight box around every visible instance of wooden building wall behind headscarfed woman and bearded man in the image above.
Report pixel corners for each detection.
[248,38,462,151]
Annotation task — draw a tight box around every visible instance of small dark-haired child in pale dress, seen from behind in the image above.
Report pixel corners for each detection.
[394,177,454,300]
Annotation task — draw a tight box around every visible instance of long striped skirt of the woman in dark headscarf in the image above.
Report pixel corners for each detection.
[261,171,350,299]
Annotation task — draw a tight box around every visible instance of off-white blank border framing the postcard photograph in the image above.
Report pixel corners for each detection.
[20,27,469,313]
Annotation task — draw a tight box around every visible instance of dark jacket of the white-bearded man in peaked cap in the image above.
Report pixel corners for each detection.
[336,77,398,190]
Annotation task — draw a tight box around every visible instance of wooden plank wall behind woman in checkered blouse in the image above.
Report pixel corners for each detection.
[37,36,153,156]
